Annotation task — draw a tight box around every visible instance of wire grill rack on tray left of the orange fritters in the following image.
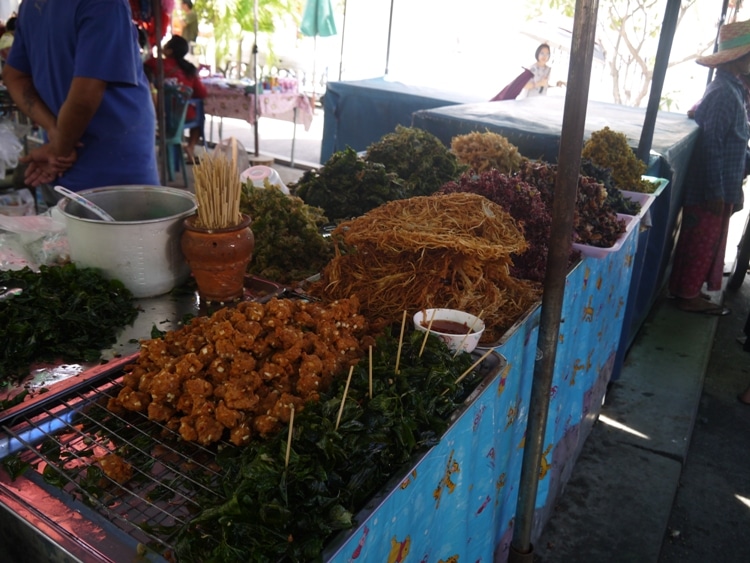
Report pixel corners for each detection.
[0,364,229,557]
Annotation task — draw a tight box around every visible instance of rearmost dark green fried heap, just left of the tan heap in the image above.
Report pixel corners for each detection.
[365,125,467,197]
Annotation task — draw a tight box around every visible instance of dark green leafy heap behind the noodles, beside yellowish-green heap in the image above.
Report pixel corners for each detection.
[289,147,406,221]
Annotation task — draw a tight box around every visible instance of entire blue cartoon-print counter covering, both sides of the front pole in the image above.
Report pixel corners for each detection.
[326,215,638,563]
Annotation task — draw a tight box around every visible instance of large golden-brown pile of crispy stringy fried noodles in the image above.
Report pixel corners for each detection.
[310,193,541,343]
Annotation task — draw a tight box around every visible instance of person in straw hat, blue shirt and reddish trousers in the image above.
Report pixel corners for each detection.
[669,21,750,316]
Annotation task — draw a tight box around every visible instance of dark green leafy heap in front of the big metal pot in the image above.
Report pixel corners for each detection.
[0,264,138,383]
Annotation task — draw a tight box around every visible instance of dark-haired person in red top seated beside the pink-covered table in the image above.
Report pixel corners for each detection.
[145,35,207,163]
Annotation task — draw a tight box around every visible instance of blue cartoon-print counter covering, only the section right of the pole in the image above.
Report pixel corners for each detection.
[532,220,640,541]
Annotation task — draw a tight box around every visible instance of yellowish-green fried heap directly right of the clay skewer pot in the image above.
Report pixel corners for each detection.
[240,182,333,284]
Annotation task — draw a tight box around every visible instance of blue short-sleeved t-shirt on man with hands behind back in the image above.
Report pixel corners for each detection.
[8,0,160,191]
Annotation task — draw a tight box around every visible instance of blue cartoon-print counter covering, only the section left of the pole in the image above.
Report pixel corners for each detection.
[325,307,539,562]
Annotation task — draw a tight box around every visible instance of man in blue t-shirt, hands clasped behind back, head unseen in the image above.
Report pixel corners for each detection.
[3,0,160,196]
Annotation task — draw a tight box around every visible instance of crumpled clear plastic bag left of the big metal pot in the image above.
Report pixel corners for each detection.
[0,212,70,271]
